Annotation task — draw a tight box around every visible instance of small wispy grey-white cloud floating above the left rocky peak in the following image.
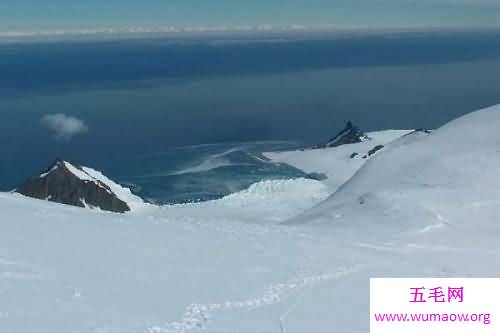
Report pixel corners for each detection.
[41,113,89,141]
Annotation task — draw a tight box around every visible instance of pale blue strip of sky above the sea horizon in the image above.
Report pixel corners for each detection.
[0,0,500,33]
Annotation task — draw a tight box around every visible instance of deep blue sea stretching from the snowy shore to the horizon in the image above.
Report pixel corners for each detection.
[0,31,500,202]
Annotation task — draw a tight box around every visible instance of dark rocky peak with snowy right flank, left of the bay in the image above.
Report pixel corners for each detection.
[16,160,143,213]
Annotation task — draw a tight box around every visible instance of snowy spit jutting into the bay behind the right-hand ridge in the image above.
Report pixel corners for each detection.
[264,130,412,191]
